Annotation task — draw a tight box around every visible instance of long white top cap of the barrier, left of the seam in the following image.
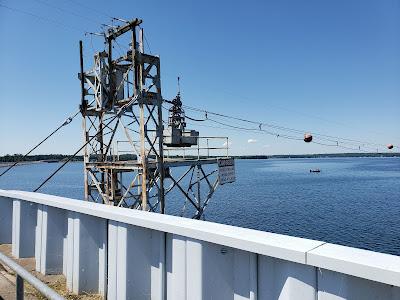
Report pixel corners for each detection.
[0,190,322,264]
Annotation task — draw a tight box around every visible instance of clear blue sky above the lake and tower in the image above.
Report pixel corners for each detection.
[0,0,400,155]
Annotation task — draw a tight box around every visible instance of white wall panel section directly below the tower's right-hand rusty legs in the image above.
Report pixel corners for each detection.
[108,222,165,299]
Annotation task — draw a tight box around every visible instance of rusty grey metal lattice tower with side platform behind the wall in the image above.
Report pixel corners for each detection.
[79,19,234,218]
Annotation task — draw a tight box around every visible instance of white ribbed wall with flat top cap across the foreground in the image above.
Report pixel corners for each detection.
[0,190,400,300]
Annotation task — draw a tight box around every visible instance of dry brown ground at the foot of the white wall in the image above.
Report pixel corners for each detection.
[0,244,103,300]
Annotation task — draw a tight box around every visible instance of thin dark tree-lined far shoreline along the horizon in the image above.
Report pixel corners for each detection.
[0,152,400,164]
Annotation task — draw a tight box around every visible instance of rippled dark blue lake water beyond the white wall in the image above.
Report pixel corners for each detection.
[0,158,400,255]
